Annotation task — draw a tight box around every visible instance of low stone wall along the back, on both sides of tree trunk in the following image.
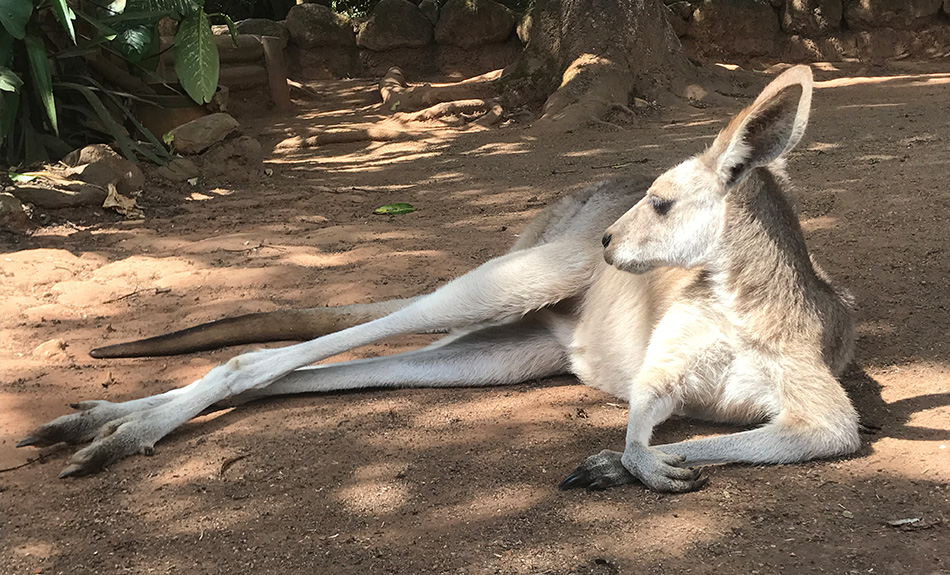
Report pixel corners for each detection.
[238,0,950,79]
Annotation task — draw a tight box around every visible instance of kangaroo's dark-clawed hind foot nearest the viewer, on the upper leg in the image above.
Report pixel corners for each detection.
[59,415,154,477]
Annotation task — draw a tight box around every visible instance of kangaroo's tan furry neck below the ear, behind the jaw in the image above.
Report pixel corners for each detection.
[710,168,821,344]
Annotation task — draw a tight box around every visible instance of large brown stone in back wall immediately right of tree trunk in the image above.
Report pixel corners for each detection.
[687,0,781,57]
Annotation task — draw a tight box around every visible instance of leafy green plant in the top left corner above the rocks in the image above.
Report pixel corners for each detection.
[0,0,233,165]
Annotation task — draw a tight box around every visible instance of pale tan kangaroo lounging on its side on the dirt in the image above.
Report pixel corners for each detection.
[19,66,860,492]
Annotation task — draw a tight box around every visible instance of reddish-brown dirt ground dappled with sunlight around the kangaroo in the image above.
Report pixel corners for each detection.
[0,63,950,575]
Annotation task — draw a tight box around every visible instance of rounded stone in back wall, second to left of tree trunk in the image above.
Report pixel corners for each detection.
[356,0,432,52]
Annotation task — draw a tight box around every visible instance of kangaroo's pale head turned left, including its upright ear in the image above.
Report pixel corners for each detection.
[603,66,812,273]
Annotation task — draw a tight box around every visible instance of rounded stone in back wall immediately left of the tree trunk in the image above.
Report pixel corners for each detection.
[435,0,518,50]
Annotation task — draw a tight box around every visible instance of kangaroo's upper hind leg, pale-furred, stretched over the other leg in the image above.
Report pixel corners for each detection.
[35,238,603,475]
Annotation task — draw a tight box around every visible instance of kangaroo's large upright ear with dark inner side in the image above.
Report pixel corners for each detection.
[703,66,812,189]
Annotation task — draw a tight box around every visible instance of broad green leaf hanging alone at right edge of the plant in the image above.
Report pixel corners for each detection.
[175,10,219,104]
